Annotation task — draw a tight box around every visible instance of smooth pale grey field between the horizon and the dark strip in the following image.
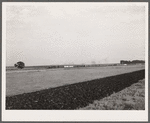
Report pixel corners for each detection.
[6,65,145,96]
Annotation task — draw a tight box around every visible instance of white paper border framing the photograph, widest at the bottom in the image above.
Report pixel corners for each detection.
[2,2,148,121]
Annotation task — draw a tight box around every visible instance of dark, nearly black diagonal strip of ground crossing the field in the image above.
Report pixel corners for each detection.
[6,70,145,109]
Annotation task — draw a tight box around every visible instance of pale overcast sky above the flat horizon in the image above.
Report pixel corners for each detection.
[6,2,145,66]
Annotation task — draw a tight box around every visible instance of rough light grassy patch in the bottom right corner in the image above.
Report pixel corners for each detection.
[79,79,145,110]
